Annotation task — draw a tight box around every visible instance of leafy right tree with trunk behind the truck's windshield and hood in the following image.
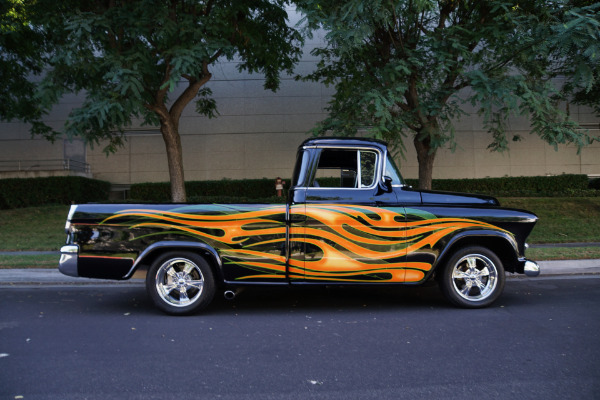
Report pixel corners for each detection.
[299,0,600,189]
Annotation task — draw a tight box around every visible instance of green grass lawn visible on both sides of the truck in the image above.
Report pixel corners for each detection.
[0,197,600,268]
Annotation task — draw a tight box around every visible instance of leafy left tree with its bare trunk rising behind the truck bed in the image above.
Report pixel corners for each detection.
[0,0,301,202]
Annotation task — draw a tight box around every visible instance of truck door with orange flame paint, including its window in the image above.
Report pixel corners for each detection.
[289,146,406,283]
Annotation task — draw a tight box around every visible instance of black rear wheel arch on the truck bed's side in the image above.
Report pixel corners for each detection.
[125,241,224,286]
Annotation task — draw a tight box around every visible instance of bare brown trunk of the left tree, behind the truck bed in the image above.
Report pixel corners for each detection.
[160,118,186,203]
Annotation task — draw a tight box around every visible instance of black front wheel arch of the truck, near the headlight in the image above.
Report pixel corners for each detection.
[433,231,519,272]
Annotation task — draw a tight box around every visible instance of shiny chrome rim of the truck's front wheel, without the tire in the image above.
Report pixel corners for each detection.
[452,254,498,301]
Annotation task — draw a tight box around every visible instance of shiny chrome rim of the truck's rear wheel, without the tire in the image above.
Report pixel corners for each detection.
[155,258,204,307]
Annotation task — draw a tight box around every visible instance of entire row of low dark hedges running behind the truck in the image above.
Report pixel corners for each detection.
[0,175,600,209]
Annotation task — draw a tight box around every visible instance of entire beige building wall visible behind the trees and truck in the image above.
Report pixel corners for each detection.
[0,79,600,184]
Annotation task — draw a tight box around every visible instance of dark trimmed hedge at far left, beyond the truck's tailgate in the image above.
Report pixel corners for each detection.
[0,176,110,209]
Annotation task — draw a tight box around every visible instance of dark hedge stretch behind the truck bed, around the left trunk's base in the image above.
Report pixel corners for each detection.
[129,179,290,203]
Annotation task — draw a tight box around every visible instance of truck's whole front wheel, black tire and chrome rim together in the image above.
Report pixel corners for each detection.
[440,246,505,308]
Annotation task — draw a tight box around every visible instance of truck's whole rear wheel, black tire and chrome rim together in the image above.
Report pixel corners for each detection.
[146,252,215,315]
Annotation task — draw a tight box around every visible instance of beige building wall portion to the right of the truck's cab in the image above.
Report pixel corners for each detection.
[398,102,600,179]
